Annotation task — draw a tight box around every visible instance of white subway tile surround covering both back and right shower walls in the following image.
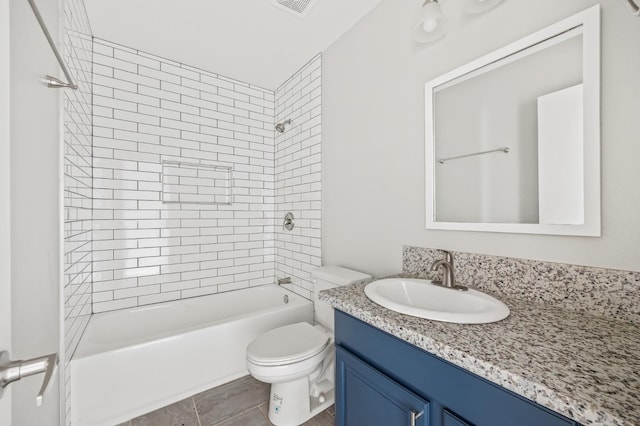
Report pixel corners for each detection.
[93,39,320,313]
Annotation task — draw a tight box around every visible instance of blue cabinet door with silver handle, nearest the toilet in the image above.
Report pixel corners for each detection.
[336,346,429,426]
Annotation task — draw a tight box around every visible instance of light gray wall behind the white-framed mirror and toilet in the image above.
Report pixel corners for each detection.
[323,0,640,275]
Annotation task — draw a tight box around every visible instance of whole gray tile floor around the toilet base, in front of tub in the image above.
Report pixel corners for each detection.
[119,376,335,426]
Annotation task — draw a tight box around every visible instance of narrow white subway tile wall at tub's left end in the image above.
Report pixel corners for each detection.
[61,0,92,418]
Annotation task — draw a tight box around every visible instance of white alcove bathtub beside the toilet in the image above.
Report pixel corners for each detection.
[70,285,313,426]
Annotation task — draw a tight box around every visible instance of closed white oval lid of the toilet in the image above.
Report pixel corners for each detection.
[247,322,329,365]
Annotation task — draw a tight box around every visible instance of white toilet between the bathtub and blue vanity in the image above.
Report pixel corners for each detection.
[247,266,371,426]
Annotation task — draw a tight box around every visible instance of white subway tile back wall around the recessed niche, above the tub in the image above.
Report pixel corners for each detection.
[93,39,276,312]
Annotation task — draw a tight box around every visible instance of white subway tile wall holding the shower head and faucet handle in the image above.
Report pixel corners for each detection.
[275,54,322,298]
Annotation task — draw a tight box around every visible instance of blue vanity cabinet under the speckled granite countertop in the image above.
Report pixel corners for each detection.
[335,310,579,426]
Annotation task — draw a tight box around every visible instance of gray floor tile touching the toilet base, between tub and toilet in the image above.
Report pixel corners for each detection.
[193,376,269,426]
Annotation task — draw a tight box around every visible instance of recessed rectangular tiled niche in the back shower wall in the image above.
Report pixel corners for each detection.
[162,161,233,205]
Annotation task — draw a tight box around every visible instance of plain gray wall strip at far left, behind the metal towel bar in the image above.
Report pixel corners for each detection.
[10,0,62,426]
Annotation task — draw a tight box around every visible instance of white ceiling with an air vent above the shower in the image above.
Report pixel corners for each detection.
[85,0,380,90]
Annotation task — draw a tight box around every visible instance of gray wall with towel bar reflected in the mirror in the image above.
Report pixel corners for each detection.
[434,36,582,223]
